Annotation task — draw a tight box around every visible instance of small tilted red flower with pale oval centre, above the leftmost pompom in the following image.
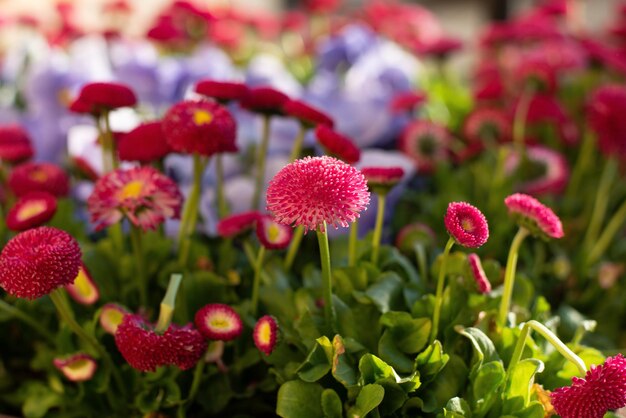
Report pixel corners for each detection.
[6,192,57,231]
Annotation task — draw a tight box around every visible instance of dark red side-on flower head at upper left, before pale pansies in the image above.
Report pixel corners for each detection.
[70,82,137,115]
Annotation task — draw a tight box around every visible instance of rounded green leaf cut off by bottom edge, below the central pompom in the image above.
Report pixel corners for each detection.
[276,380,324,418]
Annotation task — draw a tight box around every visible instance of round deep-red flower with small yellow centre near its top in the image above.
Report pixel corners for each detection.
[163,100,237,157]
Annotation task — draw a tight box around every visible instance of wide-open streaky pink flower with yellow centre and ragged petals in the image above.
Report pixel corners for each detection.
[87,166,182,231]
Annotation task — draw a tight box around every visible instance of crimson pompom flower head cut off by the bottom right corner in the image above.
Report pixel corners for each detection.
[550,354,626,418]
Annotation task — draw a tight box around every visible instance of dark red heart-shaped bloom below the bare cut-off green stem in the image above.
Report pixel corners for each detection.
[115,315,206,372]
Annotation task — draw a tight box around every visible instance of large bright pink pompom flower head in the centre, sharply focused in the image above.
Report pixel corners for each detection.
[267,156,370,232]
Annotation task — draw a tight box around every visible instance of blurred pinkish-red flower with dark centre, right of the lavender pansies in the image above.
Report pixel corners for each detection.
[398,120,452,173]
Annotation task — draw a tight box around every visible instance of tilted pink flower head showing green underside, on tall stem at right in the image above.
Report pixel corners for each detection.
[504,193,563,239]
